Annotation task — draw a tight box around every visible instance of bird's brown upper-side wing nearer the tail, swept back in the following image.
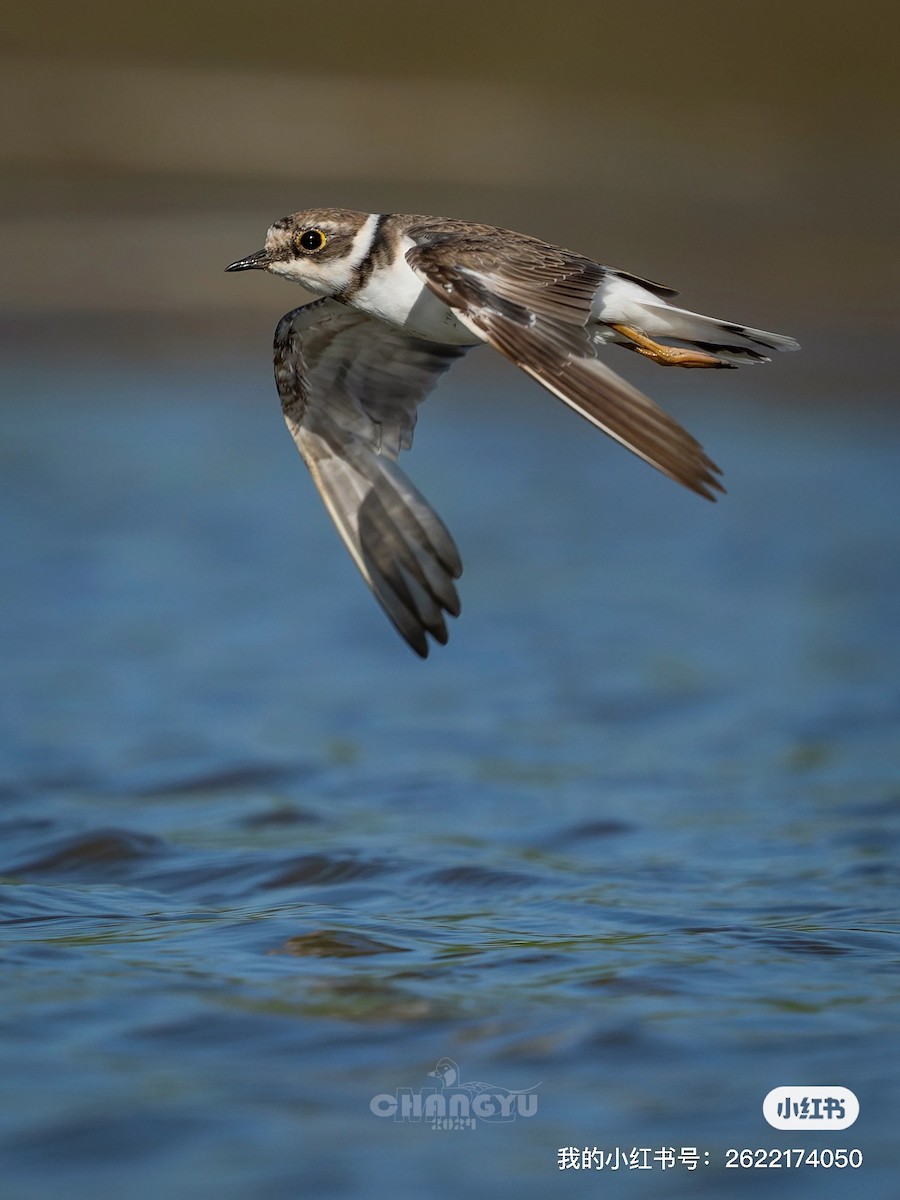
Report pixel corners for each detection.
[407,227,722,500]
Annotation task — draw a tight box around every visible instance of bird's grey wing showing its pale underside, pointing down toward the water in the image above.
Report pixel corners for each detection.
[275,299,466,658]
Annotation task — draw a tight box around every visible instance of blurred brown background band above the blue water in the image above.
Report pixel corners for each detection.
[0,0,900,374]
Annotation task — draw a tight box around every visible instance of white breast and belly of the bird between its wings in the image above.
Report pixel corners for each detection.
[353,238,482,346]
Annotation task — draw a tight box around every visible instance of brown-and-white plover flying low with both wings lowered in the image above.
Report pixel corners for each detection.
[226,209,798,658]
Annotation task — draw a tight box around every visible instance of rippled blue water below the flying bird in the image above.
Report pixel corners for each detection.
[0,345,900,1200]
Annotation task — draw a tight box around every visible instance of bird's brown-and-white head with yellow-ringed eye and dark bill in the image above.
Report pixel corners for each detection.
[226,209,373,295]
